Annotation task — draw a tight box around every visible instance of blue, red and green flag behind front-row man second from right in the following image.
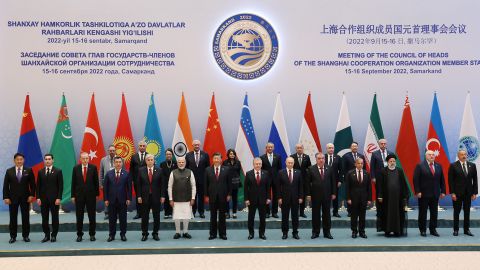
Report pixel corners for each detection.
[425,93,450,194]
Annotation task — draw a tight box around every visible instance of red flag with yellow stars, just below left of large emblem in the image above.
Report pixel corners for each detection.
[203,94,227,163]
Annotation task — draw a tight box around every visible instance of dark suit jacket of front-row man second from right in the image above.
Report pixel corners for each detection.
[413,161,446,199]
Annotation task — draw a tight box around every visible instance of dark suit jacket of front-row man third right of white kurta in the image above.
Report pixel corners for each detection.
[278,169,304,205]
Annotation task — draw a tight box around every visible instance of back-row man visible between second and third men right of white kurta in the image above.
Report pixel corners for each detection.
[260,142,282,218]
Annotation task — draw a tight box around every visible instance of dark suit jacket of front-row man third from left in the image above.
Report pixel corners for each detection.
[71,164,100,199]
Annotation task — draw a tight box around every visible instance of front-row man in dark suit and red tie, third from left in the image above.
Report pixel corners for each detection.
[71,152,100,242]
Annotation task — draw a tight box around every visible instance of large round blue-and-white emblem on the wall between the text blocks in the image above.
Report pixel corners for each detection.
[213,14,278,80]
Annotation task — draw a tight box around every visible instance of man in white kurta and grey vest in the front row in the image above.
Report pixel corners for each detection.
[168,157,197,239]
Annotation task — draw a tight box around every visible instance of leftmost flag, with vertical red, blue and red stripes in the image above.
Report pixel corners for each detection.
[18,95,43,178]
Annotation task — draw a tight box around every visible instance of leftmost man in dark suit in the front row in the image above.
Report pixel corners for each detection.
[3,153,35,244]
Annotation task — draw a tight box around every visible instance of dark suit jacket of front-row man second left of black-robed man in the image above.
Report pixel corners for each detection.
[307,164,337,202]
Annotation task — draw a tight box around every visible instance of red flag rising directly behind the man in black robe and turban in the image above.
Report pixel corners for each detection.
[395,96,420,196]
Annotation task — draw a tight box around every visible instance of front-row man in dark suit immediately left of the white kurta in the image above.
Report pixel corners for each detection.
[137,154,165,241]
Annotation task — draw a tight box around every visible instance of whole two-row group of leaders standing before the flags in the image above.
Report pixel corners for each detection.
[3,139,478,243]
